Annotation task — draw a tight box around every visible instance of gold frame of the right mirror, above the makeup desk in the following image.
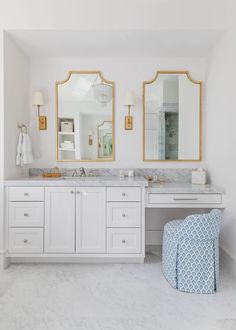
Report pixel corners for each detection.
[143,70,202,162]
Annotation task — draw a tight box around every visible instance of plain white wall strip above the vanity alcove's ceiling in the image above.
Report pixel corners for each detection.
[0,0,226,30]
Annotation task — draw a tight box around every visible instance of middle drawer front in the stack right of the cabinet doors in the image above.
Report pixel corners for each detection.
[107,202,141,227]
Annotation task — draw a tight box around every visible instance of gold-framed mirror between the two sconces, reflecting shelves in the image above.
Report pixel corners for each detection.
[56,71,115,162]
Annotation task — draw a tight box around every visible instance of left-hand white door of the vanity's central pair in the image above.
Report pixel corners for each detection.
[45,187,75,253]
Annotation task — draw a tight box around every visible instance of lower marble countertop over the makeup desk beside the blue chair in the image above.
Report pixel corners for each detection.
[146,182,224,194]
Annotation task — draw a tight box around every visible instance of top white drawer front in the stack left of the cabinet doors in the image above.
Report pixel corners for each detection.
[9,187,44,202]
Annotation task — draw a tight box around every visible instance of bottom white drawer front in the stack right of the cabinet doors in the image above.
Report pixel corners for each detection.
[107,228,141,253]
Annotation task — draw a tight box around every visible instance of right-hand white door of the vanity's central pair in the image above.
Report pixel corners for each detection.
[76,187,106,253]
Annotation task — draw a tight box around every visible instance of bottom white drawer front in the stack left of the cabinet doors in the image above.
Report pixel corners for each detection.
[9,228,43,253]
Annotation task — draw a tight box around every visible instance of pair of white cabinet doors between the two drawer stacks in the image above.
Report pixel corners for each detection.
[45,187,106,253]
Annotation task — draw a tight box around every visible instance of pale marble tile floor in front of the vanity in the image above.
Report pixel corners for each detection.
[0,254,236,330]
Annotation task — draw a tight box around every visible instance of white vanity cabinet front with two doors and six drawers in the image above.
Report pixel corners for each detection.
[7,182,145,262]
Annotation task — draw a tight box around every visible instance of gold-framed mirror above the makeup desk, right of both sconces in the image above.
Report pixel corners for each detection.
[143,71,202,161]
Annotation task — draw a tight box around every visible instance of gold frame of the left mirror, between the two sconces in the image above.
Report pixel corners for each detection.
[56,70,115,163]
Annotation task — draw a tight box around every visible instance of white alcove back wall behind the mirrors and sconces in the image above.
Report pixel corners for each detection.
[29,58,206,167]
